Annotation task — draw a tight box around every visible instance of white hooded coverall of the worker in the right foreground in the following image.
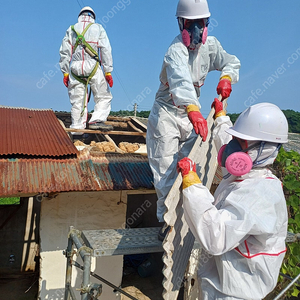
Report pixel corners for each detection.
[183,116,288,300]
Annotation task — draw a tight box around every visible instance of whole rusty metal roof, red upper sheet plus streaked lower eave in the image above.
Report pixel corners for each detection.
[0,106,153,197]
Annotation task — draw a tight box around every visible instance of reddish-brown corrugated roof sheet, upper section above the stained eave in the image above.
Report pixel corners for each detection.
[0,106,78,157]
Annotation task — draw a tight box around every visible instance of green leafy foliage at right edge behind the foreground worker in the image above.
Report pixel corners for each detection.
[274,148,300,297]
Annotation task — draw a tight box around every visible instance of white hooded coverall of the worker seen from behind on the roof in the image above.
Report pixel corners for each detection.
[59,15,113,129]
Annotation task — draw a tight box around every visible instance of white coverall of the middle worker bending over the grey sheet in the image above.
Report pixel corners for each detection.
[146,34,240,222]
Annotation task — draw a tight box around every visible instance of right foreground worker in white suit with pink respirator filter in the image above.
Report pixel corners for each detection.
[178,99,288,300]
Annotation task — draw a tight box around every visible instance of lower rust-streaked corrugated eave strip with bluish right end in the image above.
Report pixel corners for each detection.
[0,153,153,197]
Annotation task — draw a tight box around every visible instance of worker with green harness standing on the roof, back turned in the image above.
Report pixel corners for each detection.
[59,6,113,134]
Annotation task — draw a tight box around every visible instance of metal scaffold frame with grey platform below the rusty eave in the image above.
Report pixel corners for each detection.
[64,226,163,300]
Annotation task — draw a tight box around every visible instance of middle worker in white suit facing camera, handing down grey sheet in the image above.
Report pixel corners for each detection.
[146,0,240,239]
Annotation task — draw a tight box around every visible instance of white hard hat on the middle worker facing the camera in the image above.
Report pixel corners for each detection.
[176,0,210,20]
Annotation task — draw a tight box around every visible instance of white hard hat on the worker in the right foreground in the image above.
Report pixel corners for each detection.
[226,103,288,143]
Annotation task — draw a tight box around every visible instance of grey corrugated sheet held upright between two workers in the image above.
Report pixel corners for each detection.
[163,100,227,300]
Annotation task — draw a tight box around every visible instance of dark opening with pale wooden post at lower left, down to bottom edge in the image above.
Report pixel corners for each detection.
[0,198,41,300]
